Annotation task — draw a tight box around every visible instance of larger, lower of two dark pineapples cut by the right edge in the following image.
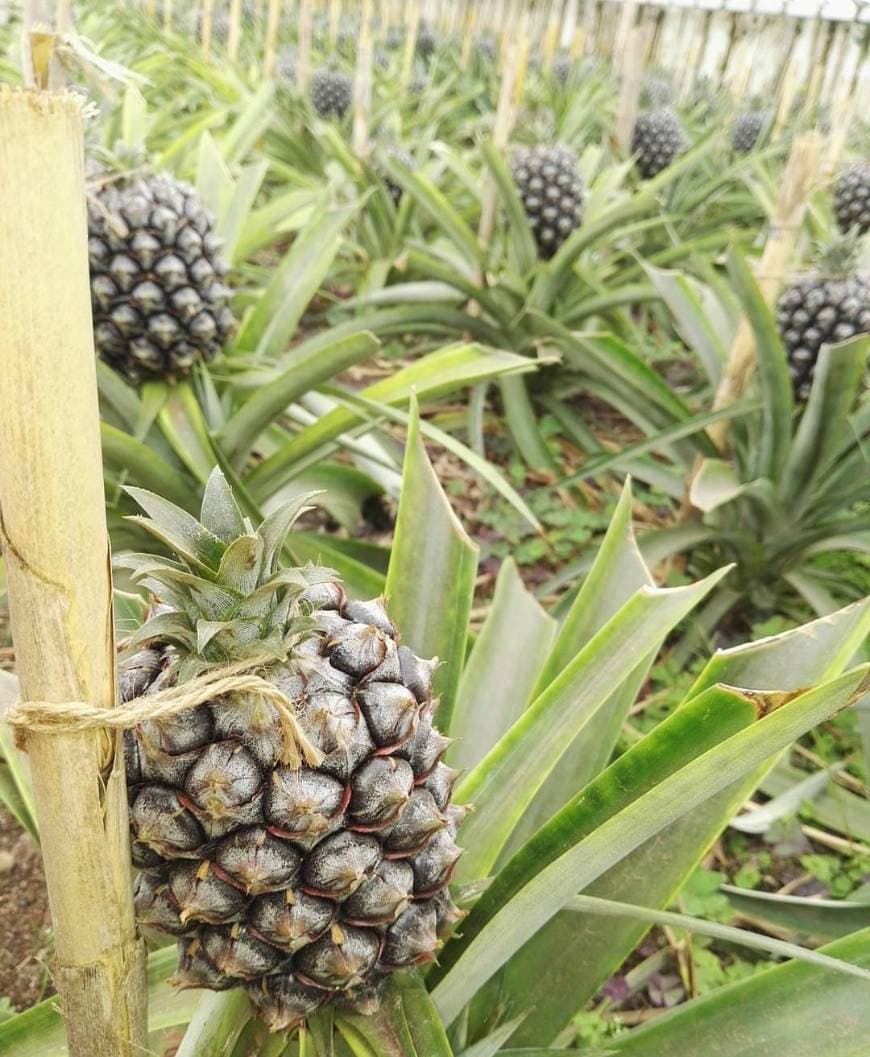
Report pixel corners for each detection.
[776,238,870,402]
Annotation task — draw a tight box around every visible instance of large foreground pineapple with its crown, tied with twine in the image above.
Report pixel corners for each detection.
[121,470,463,1031]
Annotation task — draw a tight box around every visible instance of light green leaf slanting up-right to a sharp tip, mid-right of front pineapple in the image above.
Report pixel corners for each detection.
[456,570,727,880]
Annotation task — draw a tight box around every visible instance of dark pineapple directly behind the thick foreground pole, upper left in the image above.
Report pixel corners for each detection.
[88,172,235,383]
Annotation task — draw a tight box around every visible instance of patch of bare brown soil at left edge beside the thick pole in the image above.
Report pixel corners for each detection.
[0,810,50,1009]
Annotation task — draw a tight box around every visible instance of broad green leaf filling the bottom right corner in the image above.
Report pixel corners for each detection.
[611,929,870,1057]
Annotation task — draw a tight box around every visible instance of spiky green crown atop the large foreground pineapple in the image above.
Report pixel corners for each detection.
[116,468,336,679]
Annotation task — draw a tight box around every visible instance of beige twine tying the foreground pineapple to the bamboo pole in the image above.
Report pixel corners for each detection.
[3,660,323,768]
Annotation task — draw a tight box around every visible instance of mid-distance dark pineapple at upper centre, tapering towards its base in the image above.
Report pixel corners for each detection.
[511,147,584,257]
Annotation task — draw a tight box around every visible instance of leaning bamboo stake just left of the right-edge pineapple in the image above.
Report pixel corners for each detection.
[707,132,822,450]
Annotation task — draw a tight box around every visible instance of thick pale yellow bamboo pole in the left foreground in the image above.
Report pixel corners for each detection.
[0,86,148,1057]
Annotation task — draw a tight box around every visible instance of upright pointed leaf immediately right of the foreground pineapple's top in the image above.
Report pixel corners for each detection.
[386,400,478,733]
